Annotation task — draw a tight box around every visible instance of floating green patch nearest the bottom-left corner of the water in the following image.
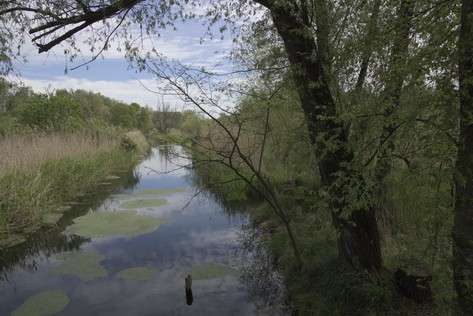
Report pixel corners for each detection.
[12,290,69,316]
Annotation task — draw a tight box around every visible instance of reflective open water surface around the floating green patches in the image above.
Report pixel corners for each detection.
[0,147,286,315]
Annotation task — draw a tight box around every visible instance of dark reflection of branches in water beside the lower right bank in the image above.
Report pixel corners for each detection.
[239,225,289,310]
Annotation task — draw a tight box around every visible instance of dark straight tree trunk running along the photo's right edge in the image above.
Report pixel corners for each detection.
[453,0,473,315]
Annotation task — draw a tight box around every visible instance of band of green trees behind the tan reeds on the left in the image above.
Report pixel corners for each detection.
[0,79,201,135]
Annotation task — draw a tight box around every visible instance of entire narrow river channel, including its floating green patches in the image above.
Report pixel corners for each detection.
[0,147,285,316]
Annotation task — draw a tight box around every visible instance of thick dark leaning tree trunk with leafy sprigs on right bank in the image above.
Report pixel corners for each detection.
[260,0,382,271]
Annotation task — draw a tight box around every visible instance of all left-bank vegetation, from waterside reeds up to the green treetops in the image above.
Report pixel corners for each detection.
[0,80,202,248]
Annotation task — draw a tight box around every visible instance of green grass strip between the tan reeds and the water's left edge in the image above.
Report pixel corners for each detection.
[0,149,138,247]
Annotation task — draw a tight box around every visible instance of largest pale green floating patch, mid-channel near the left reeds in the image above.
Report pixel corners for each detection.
[69,211,162,238]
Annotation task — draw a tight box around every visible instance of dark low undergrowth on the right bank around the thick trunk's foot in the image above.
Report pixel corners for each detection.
[189,149,453,315]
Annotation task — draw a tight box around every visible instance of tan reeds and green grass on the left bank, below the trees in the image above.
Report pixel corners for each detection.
[0,132,147,249]
